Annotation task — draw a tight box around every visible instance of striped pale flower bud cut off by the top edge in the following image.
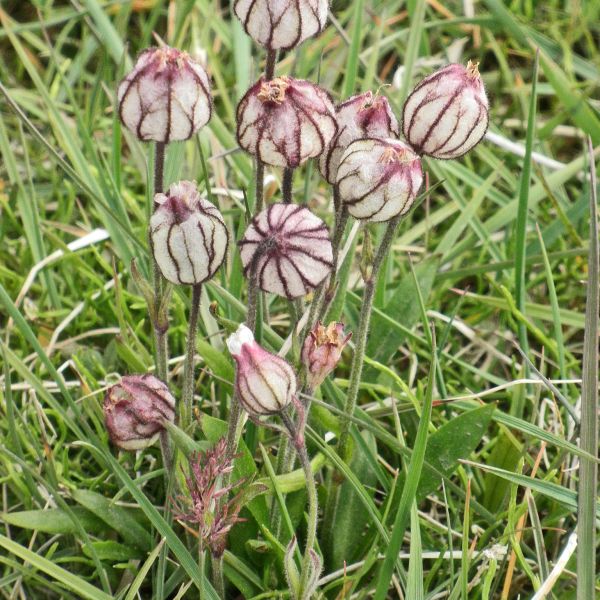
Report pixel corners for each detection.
[233,0,329,50]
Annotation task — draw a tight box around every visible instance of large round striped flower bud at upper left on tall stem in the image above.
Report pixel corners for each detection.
[117,46,212,143]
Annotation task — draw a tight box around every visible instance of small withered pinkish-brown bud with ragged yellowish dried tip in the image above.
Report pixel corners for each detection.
[302,321,352,390]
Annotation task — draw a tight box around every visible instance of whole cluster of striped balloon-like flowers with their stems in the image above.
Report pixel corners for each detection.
[104,0,488,600]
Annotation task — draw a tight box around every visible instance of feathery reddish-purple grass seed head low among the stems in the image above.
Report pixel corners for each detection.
[175,438,244,558]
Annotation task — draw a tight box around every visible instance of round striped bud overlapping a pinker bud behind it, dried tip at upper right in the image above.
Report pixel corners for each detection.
[337,138,423,223]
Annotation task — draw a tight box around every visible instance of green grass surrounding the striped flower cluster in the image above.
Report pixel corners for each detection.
[0,0,600,600]
